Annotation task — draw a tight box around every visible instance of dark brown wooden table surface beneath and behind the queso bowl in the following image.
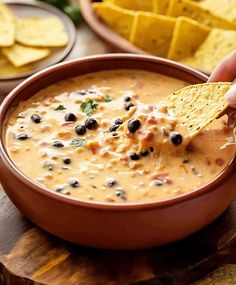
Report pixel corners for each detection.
[0,18,236,285]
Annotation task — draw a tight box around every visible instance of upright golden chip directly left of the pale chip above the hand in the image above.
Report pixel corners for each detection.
[168,17,210,60]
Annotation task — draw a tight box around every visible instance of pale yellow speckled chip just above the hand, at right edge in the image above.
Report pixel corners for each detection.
[181,29,236,73]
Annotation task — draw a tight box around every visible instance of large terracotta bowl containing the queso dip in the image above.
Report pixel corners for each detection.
[0,54,236,249]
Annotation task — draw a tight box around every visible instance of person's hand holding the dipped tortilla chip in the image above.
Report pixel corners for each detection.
[208,50,236,128]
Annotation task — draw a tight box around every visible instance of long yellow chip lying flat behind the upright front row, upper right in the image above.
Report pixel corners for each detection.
[167,0,236,29]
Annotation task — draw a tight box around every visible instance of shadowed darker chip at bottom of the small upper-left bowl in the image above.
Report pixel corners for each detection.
[0,52,32,77]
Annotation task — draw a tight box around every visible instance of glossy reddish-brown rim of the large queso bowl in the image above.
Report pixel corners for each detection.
[0,53,236,211]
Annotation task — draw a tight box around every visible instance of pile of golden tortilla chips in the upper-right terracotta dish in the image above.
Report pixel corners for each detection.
[92,0,236,73]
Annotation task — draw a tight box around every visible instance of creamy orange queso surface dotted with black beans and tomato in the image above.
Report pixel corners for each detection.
[6,70,235,203]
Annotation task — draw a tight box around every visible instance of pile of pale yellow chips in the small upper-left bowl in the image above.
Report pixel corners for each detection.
[0,2,68,76]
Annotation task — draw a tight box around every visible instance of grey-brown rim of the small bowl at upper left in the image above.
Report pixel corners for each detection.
[0,0,76,83]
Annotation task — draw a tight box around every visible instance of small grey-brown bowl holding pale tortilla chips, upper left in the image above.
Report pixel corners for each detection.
[0,0,76,94]
